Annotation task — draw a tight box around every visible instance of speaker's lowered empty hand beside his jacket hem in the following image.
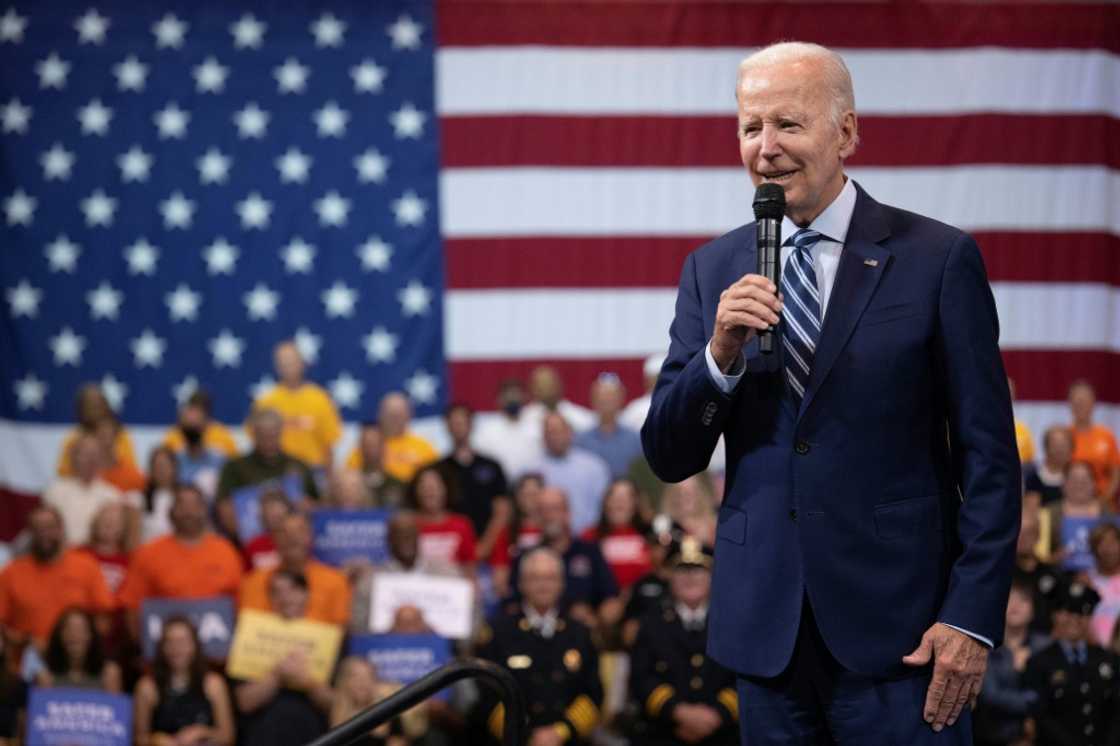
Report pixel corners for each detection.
[903,622,988,731]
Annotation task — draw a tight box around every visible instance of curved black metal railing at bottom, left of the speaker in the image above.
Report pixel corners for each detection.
[308,658,525,746]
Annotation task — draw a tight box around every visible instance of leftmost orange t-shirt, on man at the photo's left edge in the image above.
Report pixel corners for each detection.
[0,549,113,643]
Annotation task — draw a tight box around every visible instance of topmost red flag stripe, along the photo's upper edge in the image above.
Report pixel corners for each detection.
[436,0,1120,52]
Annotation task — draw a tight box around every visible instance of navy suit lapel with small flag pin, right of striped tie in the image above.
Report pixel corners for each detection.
[799,184,890,418]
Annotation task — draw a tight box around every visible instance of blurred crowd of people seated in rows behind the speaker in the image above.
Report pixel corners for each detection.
[0,343,1120,746]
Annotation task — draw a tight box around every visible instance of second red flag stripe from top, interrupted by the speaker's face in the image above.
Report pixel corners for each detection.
[440,113,1120,169]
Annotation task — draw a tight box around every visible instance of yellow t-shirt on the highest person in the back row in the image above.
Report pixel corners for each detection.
[253,383,343,467]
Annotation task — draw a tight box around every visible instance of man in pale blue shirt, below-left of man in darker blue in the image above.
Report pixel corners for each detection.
[533,413,610,533]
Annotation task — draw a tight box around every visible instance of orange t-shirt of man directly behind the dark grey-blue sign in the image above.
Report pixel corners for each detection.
[119,533,242,608]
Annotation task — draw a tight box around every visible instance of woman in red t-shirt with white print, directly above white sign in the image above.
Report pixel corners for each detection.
[408,466,475,575]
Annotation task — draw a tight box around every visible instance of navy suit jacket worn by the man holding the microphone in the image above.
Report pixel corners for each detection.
[642,185,1020,677]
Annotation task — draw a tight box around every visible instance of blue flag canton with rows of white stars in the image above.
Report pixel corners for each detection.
[0,1,447,423]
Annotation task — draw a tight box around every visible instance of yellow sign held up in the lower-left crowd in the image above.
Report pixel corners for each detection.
[226,609,343,683]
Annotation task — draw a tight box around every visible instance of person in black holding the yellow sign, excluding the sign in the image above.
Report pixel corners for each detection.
[234,570,334,746]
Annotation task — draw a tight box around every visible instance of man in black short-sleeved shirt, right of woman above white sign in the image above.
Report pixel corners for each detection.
[437,404,512,559]
